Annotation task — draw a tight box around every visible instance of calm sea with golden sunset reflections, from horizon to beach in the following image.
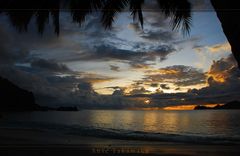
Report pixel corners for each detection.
[0,110,240,142]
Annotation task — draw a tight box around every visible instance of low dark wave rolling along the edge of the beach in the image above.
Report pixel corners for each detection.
[0,122,240,145]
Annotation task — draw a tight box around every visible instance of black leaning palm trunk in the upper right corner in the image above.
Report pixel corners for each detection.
[211,0,240,69]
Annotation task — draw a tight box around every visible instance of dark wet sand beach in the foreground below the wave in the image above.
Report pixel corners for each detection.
[0,128,240,156]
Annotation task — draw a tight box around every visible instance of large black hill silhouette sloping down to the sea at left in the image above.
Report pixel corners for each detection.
[0,77,40,111]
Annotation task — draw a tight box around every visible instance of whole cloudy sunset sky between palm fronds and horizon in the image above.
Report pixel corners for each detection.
[0,0,240,108]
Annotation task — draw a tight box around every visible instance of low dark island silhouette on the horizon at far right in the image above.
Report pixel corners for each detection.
[194,101,240,110]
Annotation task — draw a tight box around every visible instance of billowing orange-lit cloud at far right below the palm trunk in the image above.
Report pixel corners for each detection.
[192,55,240,98]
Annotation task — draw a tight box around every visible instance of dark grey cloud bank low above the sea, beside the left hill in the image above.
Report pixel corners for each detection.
[0,66,114,108]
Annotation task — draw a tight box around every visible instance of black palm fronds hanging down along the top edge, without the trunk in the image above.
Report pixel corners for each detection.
[0,0,191,34]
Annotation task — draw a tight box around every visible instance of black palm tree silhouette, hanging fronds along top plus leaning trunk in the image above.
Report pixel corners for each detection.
[0,0,240,68]
